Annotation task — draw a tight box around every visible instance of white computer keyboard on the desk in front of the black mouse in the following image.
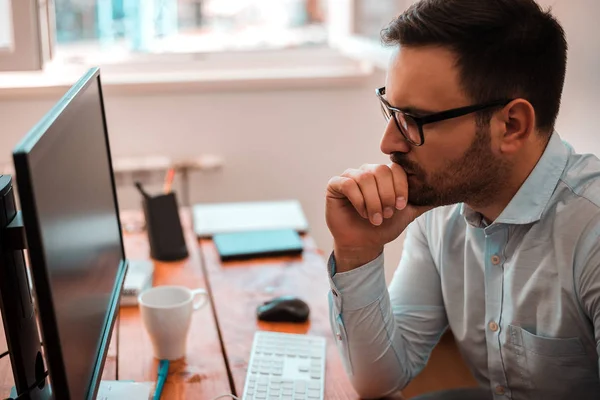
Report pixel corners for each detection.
[243,331,326,400]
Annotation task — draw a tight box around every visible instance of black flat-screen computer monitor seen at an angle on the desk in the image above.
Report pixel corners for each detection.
[9,68,127,400]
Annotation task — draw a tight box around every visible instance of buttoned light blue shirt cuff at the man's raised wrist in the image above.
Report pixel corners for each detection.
[327,253,387,313]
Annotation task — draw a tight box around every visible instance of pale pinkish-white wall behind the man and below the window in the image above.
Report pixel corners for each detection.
[0,0,600,282]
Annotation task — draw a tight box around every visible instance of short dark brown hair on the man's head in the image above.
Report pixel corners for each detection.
[381,0,567,134]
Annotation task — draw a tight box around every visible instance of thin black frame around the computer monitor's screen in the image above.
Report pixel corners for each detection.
[13,68,128,400]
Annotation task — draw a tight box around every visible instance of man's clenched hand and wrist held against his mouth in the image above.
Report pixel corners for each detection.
[325,164,431,272]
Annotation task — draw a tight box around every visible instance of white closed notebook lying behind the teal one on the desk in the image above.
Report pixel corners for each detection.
[193,200,308,238]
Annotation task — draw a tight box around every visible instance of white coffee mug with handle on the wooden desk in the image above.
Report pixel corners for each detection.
[138,286,208,360]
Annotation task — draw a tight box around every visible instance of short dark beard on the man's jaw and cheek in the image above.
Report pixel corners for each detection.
[391,123,510,207]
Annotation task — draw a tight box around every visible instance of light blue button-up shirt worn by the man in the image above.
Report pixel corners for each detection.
[329,132,600,400]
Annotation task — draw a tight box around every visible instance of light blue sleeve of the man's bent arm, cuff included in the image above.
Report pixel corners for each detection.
[328,214,448,398]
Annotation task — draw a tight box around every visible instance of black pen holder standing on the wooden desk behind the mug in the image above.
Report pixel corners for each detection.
[142,192,188,261]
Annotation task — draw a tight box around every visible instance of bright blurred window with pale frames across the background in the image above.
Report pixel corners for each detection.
[0,0,414,76]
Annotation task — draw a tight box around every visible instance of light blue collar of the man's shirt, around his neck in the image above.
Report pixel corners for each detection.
[460,132,570,228]
